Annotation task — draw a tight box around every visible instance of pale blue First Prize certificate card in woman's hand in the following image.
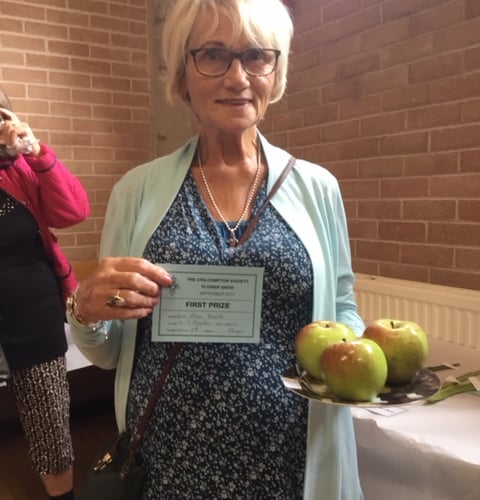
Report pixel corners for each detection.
[152,264,263,343]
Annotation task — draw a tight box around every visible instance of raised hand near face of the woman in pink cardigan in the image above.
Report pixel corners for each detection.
[0,108,40,157]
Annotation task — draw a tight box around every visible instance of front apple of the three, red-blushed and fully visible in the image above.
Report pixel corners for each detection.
[322,338,388,402]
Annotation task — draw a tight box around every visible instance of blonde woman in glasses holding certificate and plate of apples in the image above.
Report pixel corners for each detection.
[69,0,363,500]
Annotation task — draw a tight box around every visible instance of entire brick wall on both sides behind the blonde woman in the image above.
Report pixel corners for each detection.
[0,0,480,290]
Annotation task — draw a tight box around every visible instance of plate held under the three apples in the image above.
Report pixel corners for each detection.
[282,367,441,408]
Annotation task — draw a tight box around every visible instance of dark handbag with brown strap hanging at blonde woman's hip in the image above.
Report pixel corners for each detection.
[77,342,181,500]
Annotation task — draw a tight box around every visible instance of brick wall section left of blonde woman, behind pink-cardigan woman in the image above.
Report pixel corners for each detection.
[0,0,152,260]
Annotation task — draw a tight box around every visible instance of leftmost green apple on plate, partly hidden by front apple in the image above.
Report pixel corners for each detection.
[295,320,357,381]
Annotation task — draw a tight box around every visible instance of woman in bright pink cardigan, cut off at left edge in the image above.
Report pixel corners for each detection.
[0,90,89,500]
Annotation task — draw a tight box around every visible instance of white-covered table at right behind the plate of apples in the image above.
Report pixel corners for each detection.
[352,341,480,500]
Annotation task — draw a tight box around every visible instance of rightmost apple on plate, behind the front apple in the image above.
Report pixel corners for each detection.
[362,319,428,384]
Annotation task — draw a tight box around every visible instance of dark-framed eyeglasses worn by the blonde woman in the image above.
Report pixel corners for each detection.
[190,47,280,76]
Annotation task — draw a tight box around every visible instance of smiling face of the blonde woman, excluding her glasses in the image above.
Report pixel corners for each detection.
[184,14,275,137]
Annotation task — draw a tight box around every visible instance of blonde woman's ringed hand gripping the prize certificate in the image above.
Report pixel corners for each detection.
[76,257,173,324]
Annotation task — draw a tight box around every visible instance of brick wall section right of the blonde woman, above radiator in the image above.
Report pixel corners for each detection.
[262,0,480,290]
